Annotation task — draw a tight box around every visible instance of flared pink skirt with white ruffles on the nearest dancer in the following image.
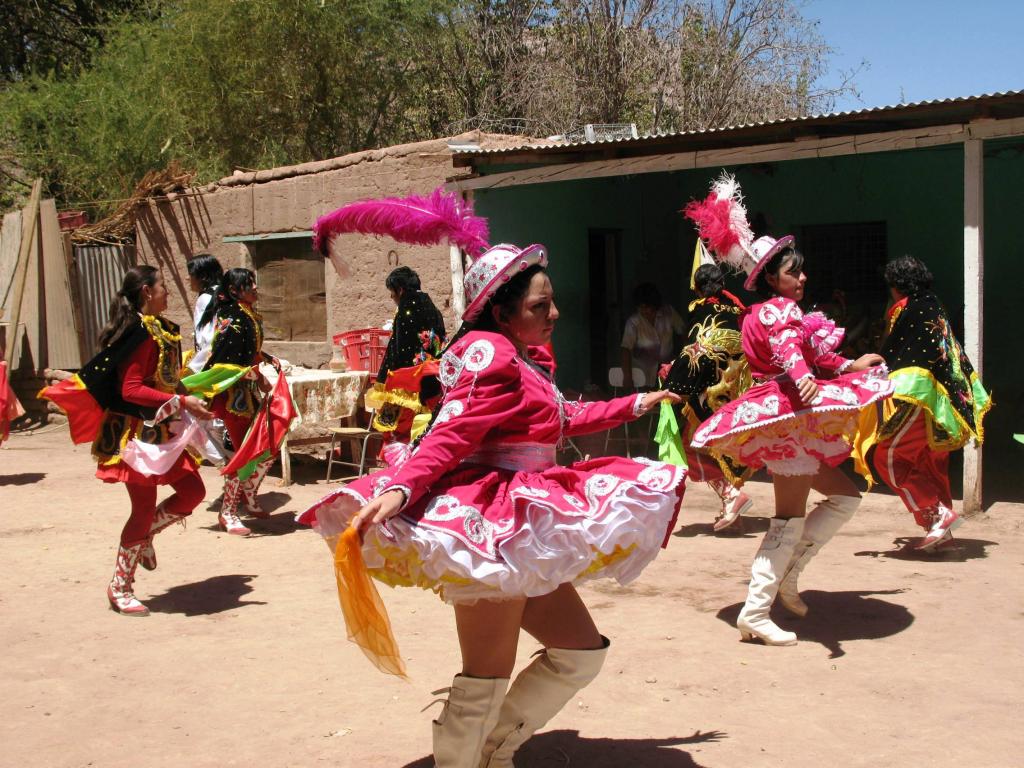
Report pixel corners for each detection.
[298,450,686,602]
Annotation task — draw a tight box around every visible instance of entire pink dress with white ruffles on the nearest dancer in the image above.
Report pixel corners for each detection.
[298,331,686,602]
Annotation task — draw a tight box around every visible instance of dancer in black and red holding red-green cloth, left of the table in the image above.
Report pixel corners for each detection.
[200,267,273,536]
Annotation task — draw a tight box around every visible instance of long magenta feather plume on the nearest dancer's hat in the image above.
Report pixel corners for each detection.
[313,187,489,255]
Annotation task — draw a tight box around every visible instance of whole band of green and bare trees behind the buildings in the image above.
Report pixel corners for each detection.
[0,0,856,217]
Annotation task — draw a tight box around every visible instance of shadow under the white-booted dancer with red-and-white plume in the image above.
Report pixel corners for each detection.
[717,590,913,658]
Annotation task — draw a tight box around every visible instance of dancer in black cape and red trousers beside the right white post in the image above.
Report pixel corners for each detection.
[872,256,992,550]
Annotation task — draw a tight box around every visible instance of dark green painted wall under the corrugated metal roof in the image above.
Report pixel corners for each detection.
[476,139,1024,498]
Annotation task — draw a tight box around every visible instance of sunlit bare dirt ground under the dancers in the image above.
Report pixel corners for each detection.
[0,428,1024,768]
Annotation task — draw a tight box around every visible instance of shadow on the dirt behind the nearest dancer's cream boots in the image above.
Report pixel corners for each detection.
[403,730,726,768]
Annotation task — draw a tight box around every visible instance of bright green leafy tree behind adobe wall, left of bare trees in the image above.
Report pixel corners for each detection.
[0,0,452,210]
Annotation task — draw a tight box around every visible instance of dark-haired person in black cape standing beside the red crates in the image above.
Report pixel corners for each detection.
[374,266,444,442]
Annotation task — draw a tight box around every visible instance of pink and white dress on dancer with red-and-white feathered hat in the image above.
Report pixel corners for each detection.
[692,297,893,475]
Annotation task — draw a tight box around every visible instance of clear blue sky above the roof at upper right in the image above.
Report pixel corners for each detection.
[803,0,1024,111]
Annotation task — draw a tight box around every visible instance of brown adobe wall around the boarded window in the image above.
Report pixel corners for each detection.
[136,132,524,368]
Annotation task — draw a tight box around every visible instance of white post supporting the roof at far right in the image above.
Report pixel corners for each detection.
[964,138,985,515]
